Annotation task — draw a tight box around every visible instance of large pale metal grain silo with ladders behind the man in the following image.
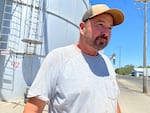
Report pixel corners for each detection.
[0,0,89,100]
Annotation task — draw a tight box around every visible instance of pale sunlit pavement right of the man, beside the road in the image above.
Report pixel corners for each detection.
[118,77,150,113]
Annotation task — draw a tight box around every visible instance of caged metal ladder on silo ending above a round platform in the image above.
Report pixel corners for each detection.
[22,0,43,55]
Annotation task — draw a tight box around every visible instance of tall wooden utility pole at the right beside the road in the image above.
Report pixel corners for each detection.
[135,0,150,94]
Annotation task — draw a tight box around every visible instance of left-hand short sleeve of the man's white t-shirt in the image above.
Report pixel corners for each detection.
[28,51,61,103]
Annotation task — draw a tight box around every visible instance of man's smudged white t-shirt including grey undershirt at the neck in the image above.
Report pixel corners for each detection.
[28,45,119,113]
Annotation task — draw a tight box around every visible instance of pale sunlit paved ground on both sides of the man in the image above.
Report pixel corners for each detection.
[0,77,150,113]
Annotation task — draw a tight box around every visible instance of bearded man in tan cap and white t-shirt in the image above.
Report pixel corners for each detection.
[24,4,124,113]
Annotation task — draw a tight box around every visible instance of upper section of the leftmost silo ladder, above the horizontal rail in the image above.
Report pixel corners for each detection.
[0,0,22,51]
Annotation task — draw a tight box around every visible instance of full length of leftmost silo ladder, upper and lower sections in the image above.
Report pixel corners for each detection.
[0,0,22,90]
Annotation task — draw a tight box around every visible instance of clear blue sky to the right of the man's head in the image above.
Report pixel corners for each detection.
[90,0,150,68]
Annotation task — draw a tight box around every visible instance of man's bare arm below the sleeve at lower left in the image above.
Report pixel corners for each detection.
[23,97,46,113]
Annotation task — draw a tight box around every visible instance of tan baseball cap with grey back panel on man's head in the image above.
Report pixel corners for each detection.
[82,4,124,26]
